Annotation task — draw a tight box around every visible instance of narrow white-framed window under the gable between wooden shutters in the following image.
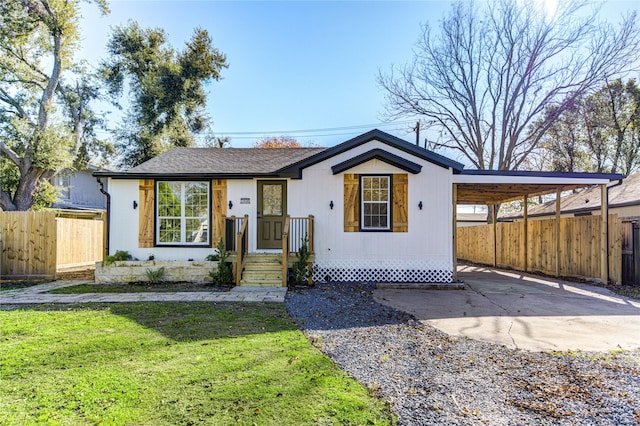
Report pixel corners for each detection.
[360,176,391,231]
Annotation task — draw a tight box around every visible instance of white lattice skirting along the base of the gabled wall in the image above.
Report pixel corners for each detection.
[313,259,453,283]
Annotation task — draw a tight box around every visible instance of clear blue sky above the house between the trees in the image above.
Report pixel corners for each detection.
[81,0,638,151]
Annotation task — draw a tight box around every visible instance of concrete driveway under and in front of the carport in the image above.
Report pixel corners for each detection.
[374,266,640,351]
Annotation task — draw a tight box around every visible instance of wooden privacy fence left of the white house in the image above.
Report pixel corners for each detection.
[0,211,104,279]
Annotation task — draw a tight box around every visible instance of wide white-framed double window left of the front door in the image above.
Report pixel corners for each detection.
[156,181,209,245]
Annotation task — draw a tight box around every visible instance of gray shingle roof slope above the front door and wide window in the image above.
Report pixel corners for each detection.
[127,148,325,175]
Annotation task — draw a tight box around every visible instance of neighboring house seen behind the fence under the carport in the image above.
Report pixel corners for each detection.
[499,173,640,220]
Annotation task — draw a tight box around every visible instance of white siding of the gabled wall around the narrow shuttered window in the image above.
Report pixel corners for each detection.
[288,141,453,282]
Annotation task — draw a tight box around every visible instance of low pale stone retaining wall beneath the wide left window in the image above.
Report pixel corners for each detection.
[95,260,218,284]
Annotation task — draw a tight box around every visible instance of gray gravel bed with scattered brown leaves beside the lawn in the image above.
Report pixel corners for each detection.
[285,284,640,425]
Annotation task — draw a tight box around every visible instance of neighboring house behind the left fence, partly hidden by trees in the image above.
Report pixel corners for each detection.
[52,164,107,210]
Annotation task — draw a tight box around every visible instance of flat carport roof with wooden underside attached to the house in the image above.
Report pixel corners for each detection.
[453,170,624,204]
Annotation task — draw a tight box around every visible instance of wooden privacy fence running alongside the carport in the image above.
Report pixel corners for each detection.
[456,215,622,283]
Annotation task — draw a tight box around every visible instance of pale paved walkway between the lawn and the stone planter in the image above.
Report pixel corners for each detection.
[0,281,287,305]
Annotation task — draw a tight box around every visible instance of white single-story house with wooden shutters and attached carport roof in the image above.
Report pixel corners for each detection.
[94,130,620,282]
